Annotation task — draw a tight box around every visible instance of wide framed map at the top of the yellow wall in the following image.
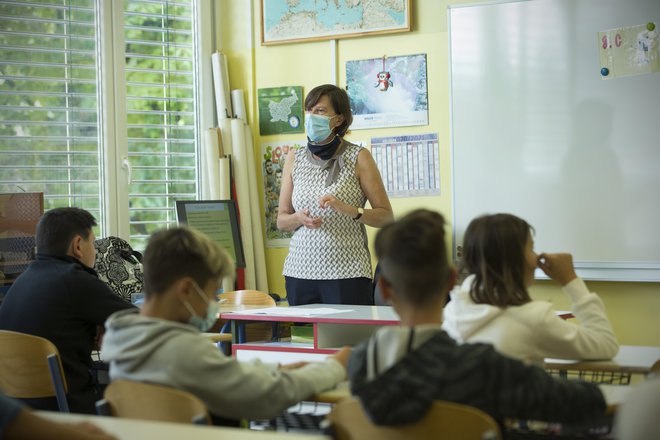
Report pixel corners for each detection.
[261,0,412,45]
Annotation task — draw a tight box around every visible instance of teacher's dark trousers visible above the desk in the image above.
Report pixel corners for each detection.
[284,277,374,306]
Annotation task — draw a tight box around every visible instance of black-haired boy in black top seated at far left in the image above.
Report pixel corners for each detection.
[0,208,133,414]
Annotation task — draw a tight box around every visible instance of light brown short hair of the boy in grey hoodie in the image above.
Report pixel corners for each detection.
[142,226,234,297]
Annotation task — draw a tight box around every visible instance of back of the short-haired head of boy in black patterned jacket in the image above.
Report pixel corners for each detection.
[375,209,451,307]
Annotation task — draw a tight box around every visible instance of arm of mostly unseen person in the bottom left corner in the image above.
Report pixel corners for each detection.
[0,393,116,440]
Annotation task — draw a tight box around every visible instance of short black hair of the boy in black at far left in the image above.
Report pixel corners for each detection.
[36,207,96,255]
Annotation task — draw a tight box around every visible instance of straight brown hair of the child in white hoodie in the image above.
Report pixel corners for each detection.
[462,214,533,307]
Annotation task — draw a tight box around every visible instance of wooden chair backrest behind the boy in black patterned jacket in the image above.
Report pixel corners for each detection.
[328,398,502,440]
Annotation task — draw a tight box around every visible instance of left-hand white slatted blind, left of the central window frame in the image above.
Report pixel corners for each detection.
[0,0,103,230]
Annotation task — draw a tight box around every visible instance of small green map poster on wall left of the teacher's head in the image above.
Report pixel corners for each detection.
[257,86,305,135]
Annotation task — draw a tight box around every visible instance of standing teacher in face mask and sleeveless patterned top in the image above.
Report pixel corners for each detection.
[277,84,393,305]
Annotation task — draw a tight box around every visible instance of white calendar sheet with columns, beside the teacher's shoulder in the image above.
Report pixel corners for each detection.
[371,133,440,197]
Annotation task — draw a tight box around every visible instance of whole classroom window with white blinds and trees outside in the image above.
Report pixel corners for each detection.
[0,0,206,249]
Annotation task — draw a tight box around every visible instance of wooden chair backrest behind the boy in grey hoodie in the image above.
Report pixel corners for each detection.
[96,380,211,424]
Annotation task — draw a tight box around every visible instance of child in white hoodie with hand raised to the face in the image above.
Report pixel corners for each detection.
[443,214,619,362]
